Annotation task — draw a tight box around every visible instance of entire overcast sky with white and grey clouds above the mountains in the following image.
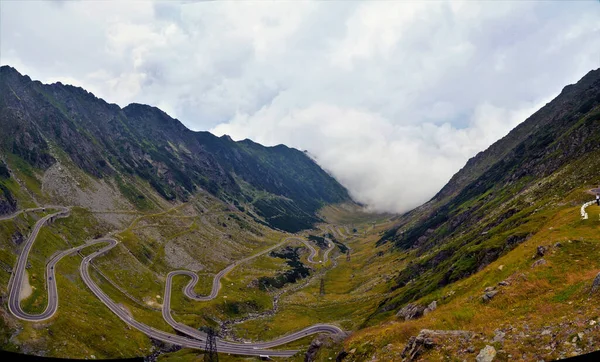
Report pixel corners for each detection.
[0,0,600,212]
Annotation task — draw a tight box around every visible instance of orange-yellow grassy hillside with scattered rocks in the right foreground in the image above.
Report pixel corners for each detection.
[345,188,600,361]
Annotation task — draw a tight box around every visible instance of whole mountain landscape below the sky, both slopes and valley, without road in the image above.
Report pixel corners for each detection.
[0,66,600,361]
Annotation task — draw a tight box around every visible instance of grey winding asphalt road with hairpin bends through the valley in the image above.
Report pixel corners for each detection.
[8,207,343,357]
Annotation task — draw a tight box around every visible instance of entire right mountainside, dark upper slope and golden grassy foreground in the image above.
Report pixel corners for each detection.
[330,69,600,361]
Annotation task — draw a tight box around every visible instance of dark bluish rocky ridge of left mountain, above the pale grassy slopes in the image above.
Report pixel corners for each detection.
[0,66,350,231]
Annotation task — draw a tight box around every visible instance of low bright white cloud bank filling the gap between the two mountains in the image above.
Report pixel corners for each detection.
[212,99,540,211]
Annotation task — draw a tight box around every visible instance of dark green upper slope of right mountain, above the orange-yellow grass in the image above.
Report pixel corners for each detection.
[378,70,600,313]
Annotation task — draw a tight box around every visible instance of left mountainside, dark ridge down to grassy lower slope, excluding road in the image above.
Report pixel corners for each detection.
[0,66,358,360]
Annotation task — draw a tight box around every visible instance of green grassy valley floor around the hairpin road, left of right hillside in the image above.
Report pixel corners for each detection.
[0,199,396,360]
